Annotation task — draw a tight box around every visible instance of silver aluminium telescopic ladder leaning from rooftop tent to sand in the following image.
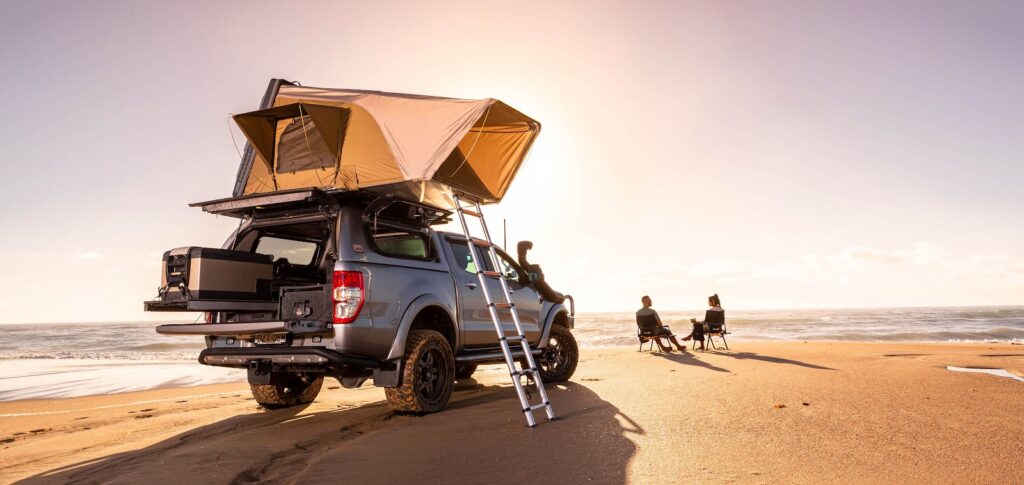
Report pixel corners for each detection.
[454,195,555,428]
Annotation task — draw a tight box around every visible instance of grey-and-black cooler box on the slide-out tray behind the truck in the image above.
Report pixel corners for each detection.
[160,247,273,302]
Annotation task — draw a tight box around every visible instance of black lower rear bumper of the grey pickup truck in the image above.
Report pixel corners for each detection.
[199,347,381,368]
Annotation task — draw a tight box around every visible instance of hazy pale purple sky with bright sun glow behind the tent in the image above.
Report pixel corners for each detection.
[0,0,1024,322]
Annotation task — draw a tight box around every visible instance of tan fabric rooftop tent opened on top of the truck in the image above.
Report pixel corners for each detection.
[234,85,541,207]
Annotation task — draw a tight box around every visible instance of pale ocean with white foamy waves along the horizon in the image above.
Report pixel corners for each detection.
[0,306,1024,401]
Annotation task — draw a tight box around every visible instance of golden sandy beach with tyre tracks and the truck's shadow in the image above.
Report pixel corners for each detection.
[0,343,1024,483]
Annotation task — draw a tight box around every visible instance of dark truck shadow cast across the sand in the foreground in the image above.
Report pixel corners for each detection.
[22,380,644,483]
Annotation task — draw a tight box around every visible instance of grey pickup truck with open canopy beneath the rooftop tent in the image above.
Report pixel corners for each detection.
[144,189,579,413]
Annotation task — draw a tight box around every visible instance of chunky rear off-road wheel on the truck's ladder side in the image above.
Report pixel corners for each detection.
[384,329,455,414]
